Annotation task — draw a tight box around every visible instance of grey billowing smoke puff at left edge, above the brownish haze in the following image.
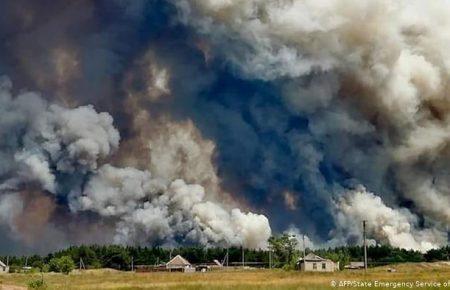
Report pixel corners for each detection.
[0,77,120,193]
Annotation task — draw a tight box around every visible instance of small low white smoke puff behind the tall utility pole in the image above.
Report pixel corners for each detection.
[335,186,447,252]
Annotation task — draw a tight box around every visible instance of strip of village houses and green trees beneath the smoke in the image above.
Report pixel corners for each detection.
[0,239,450,273]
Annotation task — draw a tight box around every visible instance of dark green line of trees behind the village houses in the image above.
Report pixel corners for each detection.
[0,235,450,272]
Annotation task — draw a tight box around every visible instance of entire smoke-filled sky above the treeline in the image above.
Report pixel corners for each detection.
[0,0,450,253]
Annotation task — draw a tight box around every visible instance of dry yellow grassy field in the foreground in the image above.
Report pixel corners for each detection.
[0,263,450,290]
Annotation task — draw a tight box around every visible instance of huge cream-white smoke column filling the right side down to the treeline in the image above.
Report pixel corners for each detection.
[176,0,450,250]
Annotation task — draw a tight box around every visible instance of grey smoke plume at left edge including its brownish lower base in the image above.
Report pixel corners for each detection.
[0,77,119,249]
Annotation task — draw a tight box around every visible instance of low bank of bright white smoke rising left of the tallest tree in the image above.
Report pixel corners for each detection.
[71,165,271,248]
